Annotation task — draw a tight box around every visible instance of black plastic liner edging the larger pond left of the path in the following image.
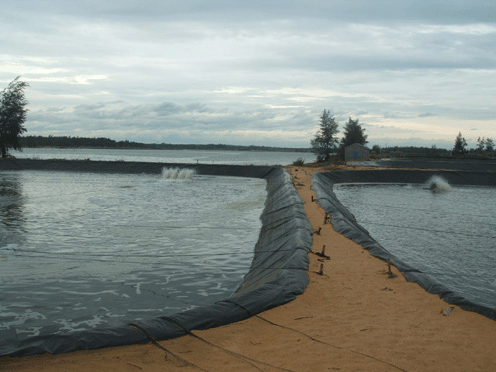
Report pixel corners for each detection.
[0,160,312,356]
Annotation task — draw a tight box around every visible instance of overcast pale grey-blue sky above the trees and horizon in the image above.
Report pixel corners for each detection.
[0,0,496,148]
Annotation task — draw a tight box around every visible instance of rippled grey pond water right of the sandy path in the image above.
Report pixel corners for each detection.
[334,184,496,309]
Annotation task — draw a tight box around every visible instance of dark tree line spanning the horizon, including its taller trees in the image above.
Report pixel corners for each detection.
[0,76,495,162]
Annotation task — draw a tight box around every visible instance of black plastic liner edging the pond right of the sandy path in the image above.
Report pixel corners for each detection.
[312,170,496,320]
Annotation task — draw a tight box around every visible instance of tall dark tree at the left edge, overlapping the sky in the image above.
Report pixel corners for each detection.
[0,76,29,158]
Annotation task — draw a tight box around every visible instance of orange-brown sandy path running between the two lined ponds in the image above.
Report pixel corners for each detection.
[0,167,496,372]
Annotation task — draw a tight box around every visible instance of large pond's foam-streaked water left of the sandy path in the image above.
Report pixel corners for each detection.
[0,171,266,342]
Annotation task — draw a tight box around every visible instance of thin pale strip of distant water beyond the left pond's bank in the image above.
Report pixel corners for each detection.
[12,149,315,165]
